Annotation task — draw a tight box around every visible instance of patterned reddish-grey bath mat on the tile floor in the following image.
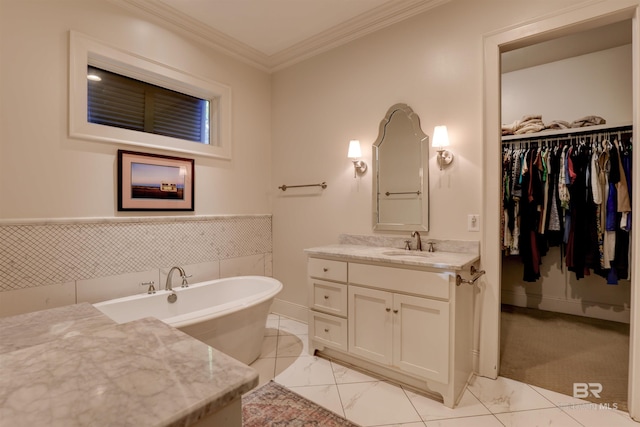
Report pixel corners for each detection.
[242,381,358,427]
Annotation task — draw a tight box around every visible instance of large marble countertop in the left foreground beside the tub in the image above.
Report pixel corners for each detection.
[0,303,258,427]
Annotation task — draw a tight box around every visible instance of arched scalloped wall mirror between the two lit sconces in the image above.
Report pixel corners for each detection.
[373,104,429,231]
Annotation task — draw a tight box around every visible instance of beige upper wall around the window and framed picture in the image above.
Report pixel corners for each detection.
[0,0,271,219]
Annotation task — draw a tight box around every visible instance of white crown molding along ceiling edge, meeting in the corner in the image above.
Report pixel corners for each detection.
[109,0,451,72]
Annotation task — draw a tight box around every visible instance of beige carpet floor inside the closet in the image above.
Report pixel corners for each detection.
[500,305,629,411]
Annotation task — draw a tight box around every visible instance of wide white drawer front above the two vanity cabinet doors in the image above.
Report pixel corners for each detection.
[349,263,453,300]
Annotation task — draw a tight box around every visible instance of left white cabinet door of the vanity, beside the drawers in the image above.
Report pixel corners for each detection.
[348,286,393,365]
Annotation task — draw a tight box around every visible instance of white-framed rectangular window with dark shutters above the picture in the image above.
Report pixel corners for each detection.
[69,31,231,159]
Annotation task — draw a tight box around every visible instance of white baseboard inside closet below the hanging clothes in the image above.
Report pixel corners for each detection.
[501,290,631,323]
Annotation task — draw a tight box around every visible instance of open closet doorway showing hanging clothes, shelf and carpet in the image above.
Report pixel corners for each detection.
[499,20,633,411]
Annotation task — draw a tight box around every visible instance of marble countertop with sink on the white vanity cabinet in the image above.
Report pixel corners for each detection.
[305,244,480,270]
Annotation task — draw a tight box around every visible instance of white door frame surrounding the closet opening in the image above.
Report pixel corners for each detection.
[476,0,640,421]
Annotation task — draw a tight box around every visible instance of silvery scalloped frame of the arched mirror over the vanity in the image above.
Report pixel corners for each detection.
[372,103,429,231]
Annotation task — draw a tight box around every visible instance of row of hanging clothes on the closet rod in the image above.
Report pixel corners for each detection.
[501,131,632,284]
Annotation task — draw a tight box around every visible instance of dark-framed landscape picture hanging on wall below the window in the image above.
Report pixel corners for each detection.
[118,150,194,211]
